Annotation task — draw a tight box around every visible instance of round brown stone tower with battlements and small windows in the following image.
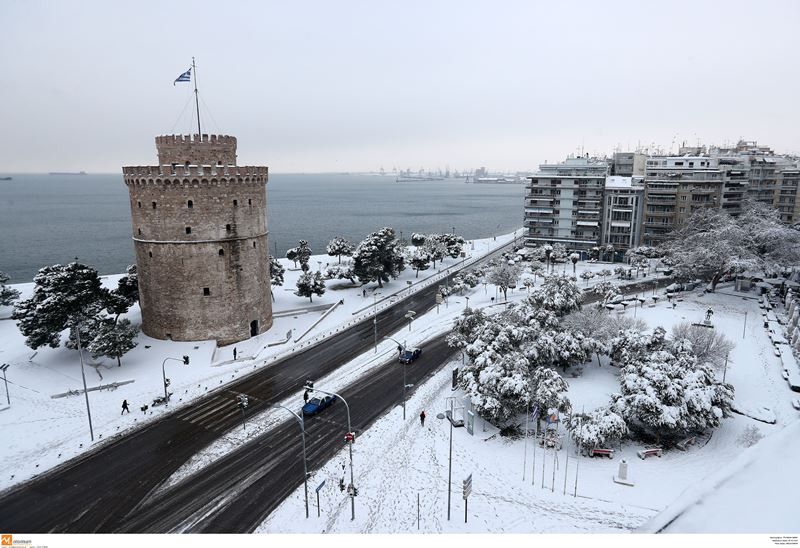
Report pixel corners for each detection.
[122,134,272,345]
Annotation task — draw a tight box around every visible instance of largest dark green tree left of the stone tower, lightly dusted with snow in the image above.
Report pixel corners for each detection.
[11,261,107,350]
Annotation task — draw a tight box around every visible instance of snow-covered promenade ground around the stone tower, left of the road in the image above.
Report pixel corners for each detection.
[0,227,524,489]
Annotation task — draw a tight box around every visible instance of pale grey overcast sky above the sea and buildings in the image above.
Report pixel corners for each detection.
[0,0,800,172]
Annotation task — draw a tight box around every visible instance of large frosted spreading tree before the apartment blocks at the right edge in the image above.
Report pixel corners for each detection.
[663,200,800,291]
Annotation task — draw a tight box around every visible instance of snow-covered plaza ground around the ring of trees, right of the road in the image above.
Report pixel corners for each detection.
[258,286,800,533]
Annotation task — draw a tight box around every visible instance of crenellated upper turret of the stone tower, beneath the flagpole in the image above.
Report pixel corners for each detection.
[156,133,236,165]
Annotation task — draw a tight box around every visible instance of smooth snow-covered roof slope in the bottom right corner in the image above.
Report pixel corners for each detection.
[637,421,800,534]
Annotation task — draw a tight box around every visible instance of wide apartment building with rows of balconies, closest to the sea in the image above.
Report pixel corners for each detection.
[524,157,609,250]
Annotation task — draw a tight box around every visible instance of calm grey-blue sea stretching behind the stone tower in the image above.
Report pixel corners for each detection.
[0,173,524,283]
